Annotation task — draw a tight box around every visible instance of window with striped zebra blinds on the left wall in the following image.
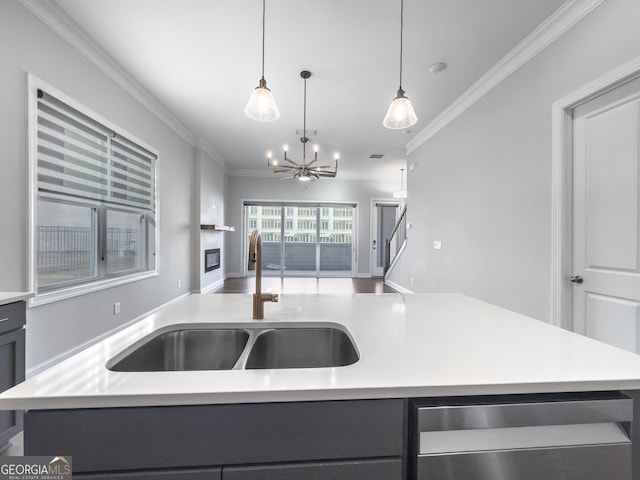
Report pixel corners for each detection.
[32,84,157,296]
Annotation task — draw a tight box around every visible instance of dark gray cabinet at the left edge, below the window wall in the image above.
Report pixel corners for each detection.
[0,301,25,452]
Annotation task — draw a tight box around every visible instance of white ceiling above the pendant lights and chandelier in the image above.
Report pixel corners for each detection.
[55,0,564,181]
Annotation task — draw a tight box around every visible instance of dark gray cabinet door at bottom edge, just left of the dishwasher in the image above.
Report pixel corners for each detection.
[222,459,402,480]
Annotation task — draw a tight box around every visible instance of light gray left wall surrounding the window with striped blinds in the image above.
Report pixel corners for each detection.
[0,0,224,368]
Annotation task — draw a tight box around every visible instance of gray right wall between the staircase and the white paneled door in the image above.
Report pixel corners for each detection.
[384,0,640,321]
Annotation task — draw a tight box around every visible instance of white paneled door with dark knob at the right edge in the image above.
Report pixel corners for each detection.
[571,79,640,353]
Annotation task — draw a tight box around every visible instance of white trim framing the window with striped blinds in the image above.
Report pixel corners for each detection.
[27,73,160,307]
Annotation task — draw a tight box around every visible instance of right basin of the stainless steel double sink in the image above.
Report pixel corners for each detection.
[245,328,359,369]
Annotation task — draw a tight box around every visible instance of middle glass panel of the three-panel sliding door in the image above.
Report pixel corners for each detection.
[283,206,318,277]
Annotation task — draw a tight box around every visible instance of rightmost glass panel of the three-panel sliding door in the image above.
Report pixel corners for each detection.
[318,207,354,277]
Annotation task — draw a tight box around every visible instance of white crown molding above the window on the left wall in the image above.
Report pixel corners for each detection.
[18,0,196,147]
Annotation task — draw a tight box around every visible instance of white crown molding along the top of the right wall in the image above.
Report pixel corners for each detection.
[407,0,604,154]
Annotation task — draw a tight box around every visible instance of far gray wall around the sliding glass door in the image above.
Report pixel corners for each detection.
[226,172,398,276]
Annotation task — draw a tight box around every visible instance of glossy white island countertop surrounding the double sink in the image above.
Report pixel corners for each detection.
[0,294,640,409]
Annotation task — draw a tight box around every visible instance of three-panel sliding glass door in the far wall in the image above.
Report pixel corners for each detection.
[245,203,355,277]
